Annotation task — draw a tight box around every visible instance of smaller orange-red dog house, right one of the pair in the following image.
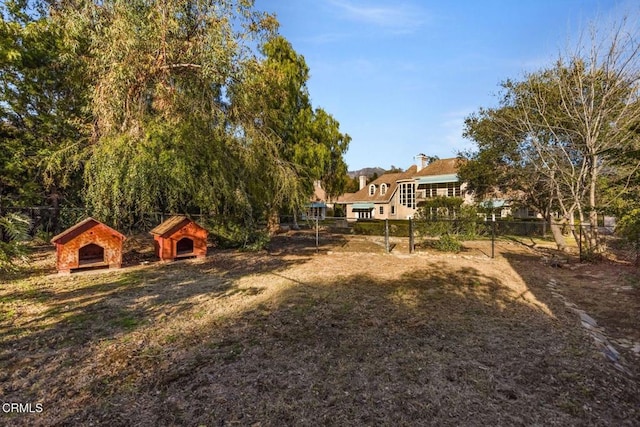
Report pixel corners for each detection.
[150,215,209,261]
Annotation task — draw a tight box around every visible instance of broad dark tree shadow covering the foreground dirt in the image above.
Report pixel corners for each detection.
[3,256,640,426]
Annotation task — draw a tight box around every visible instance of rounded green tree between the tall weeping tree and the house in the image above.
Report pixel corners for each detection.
[232,36,351,210]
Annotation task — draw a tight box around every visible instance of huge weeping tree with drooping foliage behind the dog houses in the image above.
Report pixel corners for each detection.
[57,0,318,234]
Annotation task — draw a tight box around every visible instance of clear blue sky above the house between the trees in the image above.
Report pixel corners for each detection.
[255,0,635,170]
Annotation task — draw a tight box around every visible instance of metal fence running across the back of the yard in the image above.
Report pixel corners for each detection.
[5,206,640,263]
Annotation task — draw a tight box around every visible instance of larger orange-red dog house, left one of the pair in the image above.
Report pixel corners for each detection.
[51,217,126,273]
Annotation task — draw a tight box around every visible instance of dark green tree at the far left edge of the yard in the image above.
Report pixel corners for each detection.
[0,1,88,228]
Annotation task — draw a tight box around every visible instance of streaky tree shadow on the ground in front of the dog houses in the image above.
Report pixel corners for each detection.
[0,251,308,424]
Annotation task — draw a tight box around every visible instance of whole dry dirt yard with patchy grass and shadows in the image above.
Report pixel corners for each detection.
[0,233,640,426]
